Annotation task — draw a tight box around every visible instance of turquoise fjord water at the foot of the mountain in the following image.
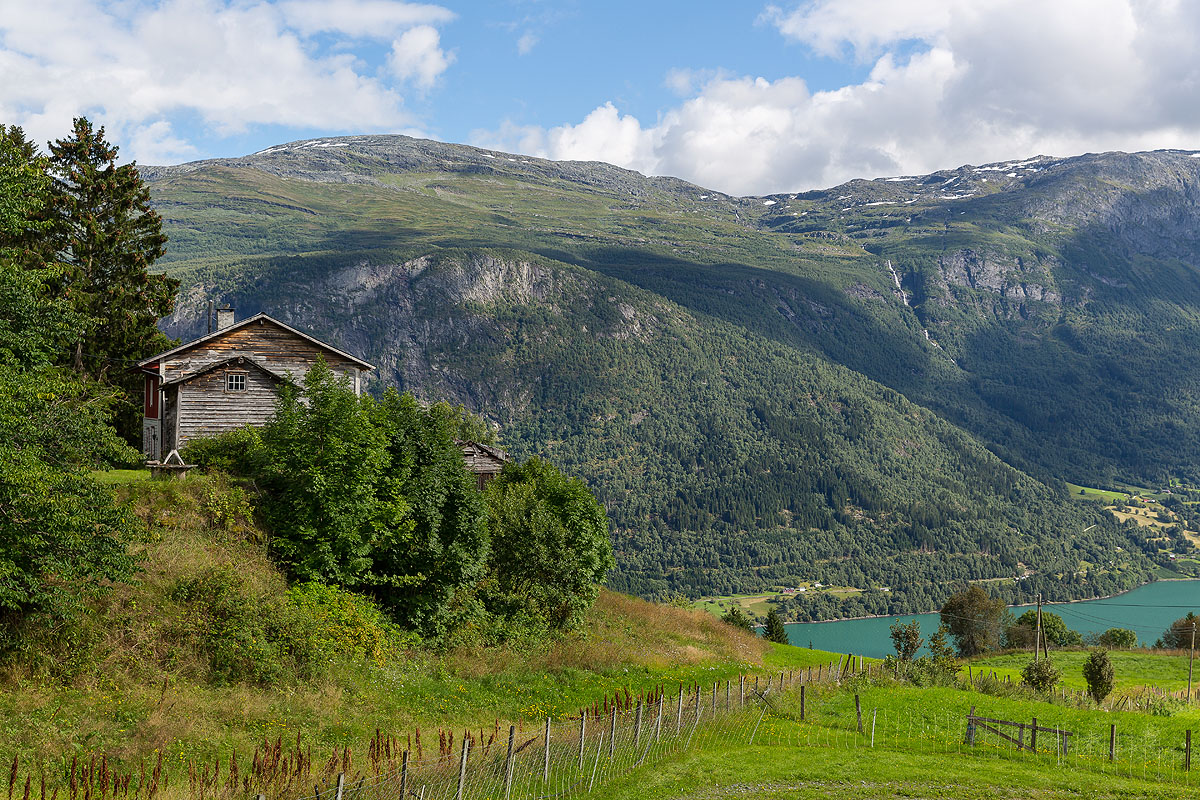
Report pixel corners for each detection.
[785,581,1200,658]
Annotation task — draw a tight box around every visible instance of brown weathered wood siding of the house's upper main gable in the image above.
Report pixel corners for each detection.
[162,319,360,390]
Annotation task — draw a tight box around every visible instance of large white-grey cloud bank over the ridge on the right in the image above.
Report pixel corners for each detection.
[479,0,1200,194]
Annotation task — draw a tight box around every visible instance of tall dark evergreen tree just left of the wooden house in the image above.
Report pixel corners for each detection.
[44,118,179,380]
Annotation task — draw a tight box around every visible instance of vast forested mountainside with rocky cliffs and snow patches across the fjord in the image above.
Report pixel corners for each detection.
[136,136,1200,614]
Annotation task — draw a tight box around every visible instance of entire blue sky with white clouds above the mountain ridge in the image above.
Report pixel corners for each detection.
[0,0,1200,194]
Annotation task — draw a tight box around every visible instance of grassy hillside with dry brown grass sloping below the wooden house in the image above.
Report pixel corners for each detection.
[0,473,806,765]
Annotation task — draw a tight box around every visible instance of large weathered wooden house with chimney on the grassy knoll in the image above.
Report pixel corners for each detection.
[137,308,374,462]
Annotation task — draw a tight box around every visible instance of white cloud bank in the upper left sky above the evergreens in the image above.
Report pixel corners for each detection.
[0,0,452,163]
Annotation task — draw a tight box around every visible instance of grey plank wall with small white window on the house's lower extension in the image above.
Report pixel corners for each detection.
[179,365,278,443]
